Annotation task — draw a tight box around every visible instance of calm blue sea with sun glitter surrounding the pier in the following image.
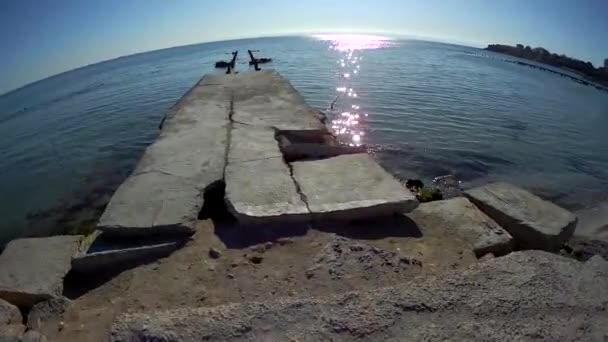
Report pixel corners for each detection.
[0,36,608,242]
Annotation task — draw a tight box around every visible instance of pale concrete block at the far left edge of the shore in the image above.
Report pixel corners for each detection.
[0,236,82,308]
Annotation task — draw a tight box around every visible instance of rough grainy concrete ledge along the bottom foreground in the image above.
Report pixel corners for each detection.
[111,251,608,341]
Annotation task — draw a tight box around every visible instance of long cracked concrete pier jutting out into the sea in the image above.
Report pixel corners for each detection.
[98,72,417,232]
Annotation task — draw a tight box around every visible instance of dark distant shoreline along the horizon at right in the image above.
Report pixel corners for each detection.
[484,44,608,91]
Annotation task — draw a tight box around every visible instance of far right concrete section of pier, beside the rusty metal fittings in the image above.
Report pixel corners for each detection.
[232,71,327,136]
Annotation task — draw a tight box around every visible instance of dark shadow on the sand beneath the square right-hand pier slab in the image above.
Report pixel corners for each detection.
[313,215,422,240]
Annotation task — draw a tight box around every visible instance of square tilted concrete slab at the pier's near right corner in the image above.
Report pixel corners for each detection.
[292,153,418,220]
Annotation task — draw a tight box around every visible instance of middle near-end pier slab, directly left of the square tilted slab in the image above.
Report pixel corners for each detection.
[225,158,309,224]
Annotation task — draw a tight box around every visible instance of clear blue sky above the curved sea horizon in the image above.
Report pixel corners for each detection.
[0,0,608,94]
